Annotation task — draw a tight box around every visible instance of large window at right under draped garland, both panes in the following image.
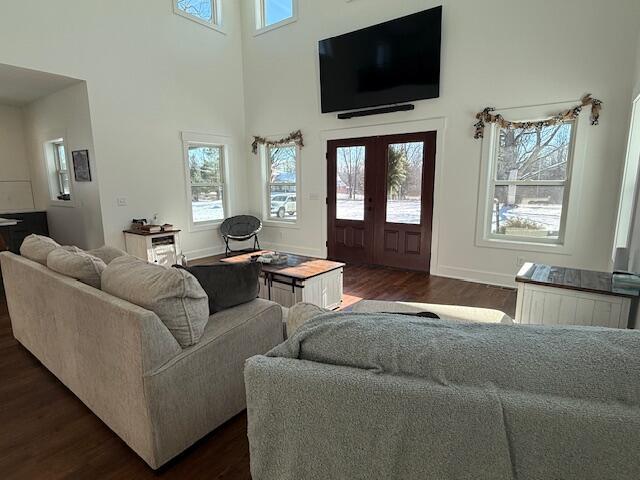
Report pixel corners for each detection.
[485,122,575,244]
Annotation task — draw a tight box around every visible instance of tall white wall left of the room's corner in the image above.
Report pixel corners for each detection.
[0,0,248,254]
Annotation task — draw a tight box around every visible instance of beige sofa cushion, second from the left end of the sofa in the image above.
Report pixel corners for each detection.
[47,247,107,288]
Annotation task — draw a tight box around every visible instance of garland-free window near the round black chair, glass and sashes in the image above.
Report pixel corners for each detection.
[184,140,227,228]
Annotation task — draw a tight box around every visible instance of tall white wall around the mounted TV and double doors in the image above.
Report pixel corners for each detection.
[243,0,640,285]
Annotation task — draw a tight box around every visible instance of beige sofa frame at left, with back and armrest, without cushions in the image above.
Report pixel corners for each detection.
[0,252,283,469]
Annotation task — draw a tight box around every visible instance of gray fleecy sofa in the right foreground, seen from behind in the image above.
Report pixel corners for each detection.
[245,310,640,480]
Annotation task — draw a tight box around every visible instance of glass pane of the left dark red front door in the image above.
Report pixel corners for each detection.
[336,145,366,220]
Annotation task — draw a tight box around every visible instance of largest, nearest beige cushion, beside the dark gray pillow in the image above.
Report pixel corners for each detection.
[102,255,209,348]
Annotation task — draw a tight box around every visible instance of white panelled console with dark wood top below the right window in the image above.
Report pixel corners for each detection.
[516,263,637,328]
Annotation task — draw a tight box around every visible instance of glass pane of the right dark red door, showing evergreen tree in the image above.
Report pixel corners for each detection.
[387,142,424,225]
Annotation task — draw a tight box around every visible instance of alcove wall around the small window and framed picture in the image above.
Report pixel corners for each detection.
[24,82,104,248]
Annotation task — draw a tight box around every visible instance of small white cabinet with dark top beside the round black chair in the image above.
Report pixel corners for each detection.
[124,230,182,267]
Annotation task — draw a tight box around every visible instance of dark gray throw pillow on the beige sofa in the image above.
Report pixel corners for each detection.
[174,262,262,315]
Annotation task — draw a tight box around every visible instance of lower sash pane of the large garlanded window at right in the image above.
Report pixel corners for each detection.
[491,185,564,240]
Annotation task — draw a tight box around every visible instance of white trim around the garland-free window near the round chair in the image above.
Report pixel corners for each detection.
[182,132,232,232]
